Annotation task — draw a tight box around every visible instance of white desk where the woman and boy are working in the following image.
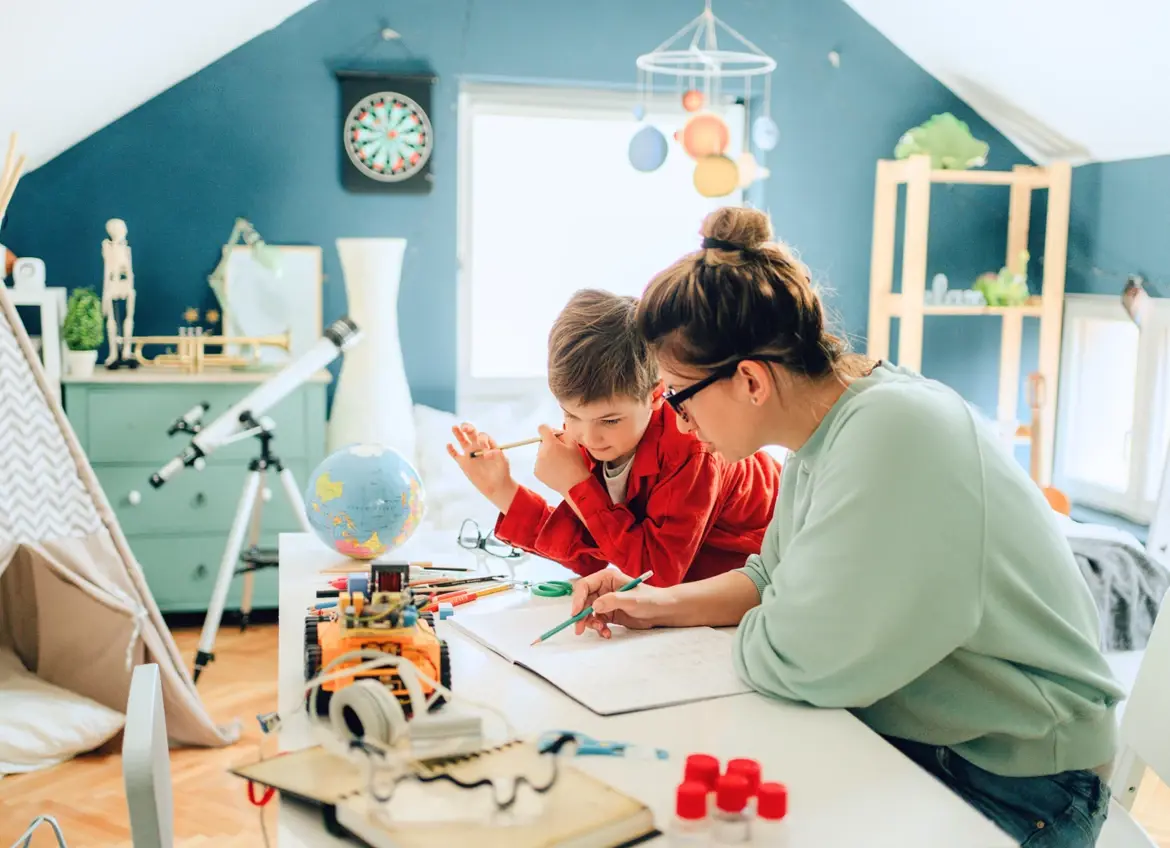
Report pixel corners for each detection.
[277,533,1016,848]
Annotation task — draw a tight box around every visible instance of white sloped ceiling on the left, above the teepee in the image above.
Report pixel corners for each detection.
[0,0,312,173]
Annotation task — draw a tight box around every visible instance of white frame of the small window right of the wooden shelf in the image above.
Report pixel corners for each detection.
[1057,294,1170,524]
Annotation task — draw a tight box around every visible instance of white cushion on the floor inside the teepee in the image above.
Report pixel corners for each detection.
[0,647,126,775]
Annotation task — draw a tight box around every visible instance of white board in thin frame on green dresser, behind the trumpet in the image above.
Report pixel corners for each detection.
[222,244,324,368]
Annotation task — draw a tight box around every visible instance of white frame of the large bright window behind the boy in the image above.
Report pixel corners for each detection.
[455,81,750,411]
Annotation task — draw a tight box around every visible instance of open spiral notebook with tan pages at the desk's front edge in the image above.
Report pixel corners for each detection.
[232,740,659,848]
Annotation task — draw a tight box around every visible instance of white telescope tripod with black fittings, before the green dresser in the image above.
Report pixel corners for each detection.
[193,412,312,683]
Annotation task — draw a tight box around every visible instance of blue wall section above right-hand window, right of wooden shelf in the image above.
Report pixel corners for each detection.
[1067,156,1170,297]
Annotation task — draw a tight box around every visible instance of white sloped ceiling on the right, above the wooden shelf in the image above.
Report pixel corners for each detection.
[841,0,1170,164]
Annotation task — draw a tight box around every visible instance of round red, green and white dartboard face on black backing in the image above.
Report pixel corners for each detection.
[344,91,433,182]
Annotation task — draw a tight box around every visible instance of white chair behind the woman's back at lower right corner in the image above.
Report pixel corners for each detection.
[1097,591,1170,848]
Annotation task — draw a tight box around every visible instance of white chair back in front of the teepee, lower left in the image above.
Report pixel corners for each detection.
[122,663,174,848]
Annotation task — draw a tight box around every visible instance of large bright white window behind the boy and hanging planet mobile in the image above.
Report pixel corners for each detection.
[459,84,745,409]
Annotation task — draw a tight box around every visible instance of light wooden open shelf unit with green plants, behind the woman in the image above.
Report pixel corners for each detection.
[867,156,1072,485]
